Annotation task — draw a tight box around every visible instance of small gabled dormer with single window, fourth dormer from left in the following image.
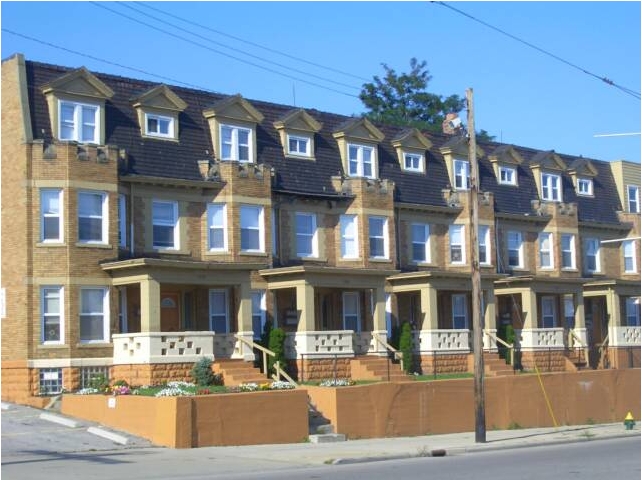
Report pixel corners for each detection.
[274,109,322,160]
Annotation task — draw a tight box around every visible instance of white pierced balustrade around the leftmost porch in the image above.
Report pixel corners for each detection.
[112,332,215,365]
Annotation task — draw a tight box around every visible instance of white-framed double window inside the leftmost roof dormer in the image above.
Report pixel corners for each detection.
[58,100,100,143]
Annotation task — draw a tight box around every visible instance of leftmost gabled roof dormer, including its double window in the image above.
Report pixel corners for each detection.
[41,67,114,145]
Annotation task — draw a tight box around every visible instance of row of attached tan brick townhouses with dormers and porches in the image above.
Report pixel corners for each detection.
[1,54,641,401]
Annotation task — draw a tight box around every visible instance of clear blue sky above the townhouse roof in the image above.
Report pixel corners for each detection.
[0,1,641,162]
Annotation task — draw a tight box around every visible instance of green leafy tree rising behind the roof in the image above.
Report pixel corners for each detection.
[359,58,494,141]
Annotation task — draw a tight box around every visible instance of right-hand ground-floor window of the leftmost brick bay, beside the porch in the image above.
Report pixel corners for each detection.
[80,287,109,343]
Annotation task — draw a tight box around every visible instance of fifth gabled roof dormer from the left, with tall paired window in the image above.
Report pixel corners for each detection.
[332,117,385,178]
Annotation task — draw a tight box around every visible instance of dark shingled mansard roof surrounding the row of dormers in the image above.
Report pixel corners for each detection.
[26,61,622,223]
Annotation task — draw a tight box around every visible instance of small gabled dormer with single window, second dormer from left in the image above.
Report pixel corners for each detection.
[132,85,187,140]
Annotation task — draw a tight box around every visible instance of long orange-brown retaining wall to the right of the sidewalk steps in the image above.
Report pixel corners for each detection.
[307,369,640,439]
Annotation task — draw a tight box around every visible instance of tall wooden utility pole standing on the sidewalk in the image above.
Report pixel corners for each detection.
[466,88,486,443]
